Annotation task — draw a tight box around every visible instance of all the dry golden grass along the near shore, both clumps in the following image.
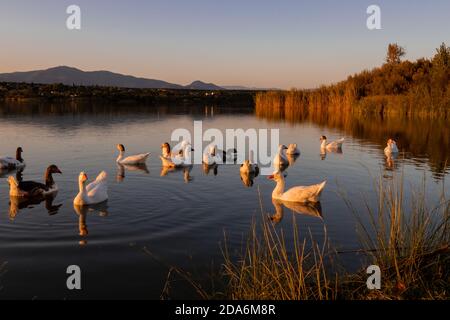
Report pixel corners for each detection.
[210,174,450,300]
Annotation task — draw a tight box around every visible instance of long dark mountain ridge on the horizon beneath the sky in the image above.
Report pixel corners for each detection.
[0,66,224,90]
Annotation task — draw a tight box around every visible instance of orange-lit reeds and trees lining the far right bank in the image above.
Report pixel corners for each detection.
[255,43,450,118]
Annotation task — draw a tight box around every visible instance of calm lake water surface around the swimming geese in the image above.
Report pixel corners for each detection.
[0,105,450,299]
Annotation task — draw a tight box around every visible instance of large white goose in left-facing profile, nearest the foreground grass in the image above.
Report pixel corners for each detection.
[268,171,327,203]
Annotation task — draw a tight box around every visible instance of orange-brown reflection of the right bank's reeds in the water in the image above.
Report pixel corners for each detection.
[256,107,450,179]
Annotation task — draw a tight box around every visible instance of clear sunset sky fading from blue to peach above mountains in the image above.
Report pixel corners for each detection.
[0,0,450,88]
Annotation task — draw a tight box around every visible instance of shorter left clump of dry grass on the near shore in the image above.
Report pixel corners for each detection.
[223,218,336,300]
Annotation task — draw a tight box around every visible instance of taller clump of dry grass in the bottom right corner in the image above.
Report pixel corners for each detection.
[342,177,450,299]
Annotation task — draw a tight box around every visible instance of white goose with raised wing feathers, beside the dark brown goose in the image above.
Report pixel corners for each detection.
[73,171,108,206]
